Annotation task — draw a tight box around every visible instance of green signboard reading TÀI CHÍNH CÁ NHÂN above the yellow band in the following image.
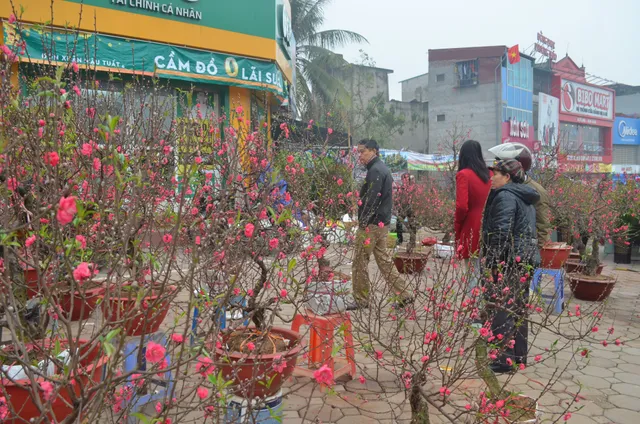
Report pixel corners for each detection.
[64,0,276,40]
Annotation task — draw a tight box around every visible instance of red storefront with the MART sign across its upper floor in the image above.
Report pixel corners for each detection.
[552,74,615,173]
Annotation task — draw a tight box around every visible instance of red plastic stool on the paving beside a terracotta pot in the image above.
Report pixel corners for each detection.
[291,310,356,378]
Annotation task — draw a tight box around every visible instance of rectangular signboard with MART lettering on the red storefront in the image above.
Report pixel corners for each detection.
[560,79,614,120]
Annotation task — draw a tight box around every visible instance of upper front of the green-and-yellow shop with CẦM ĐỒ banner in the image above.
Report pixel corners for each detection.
[0,0,295,129]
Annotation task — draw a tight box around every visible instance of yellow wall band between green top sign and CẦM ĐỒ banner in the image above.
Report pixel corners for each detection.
[0,0,276,61]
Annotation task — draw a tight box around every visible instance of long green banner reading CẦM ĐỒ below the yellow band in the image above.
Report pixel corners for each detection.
[3,22,287,100]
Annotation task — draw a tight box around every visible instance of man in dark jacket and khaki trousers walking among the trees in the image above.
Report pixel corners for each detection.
[350,140,411,309]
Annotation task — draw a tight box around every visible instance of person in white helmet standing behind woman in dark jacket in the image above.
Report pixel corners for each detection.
[489,143,551,249]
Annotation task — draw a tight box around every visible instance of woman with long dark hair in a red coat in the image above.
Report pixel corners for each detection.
[455,140,491,267]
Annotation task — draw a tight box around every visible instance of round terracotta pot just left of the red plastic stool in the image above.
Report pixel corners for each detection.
[215,327,302,398]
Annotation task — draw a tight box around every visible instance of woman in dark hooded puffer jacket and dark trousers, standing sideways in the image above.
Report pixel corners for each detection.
[482,159,540,372]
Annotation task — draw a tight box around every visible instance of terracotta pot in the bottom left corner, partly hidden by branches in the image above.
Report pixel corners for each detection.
[2,340,109,424]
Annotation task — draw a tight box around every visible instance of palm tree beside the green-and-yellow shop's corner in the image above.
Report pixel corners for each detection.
[291,0,368,115]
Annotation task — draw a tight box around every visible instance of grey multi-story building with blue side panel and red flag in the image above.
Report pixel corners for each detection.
[426,46,535,157]
